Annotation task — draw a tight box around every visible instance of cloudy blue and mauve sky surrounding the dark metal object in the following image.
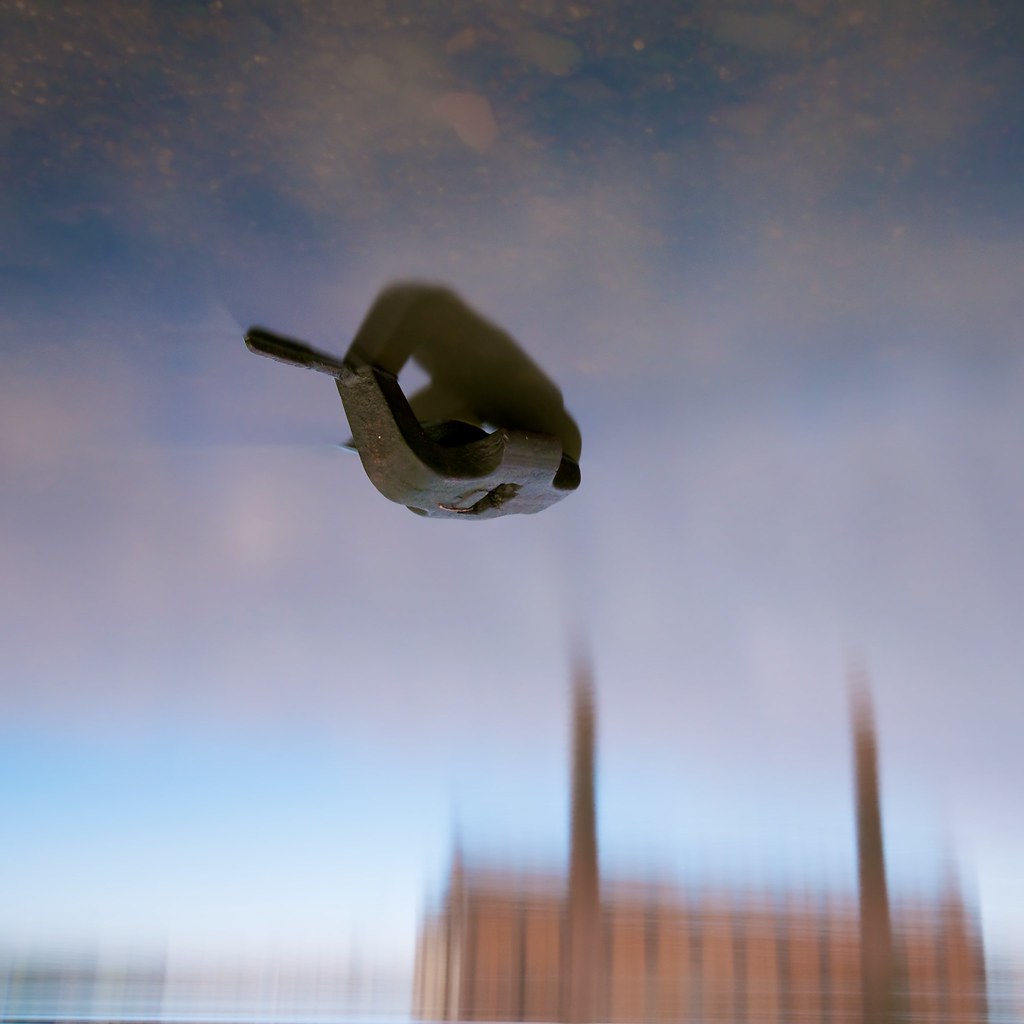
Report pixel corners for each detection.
[0,0,1024,963]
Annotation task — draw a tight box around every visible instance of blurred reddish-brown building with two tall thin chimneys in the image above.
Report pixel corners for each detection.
[414,672,988,1024]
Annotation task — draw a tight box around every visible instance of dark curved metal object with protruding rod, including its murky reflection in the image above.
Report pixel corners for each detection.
[246,285,581,519]
